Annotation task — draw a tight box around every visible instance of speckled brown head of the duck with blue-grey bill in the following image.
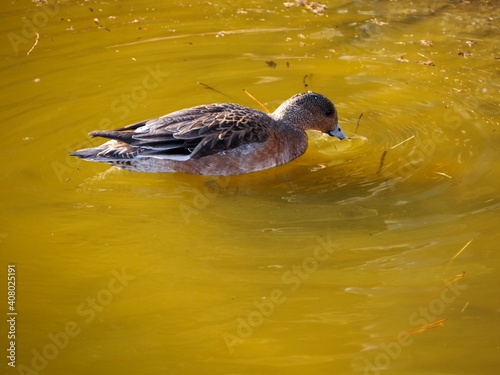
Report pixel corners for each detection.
[272,91,348,139]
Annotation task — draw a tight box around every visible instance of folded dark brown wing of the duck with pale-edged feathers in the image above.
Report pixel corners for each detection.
[85,104,274,160]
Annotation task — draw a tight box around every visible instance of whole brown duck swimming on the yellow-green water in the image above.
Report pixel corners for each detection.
[71,91,348,176]
